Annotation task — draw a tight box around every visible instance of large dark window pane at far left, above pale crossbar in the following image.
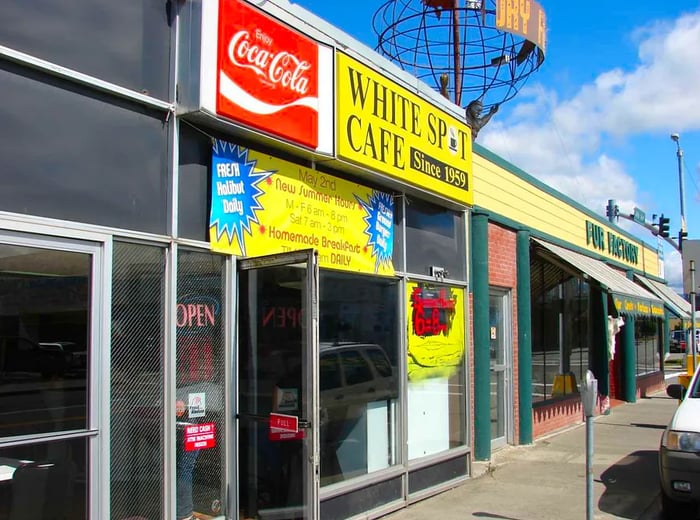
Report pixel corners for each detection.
[0,244,91,436]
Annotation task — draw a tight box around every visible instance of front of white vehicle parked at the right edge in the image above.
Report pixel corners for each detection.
[659,371,700,519]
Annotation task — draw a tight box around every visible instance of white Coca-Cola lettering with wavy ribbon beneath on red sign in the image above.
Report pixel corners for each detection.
[219,30,318,115]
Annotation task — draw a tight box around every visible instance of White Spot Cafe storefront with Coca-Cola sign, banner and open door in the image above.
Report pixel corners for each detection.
[172,0,471,519]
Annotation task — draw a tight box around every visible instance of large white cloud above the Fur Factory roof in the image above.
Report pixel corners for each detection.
[479,11,700,288]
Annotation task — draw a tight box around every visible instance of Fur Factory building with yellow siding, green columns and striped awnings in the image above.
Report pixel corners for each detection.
[471,145,683,458]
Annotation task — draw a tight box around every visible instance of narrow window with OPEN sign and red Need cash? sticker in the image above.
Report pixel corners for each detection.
[172,251,226,519]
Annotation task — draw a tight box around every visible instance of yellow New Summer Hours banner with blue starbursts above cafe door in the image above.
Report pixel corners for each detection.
[209,141,394,275]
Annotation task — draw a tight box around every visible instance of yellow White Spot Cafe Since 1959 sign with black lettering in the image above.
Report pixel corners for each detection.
[336,52,473,204]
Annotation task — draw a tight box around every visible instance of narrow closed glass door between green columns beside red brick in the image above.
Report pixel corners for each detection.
[489,289,512,449]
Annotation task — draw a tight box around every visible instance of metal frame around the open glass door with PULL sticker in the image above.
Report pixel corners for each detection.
[237,249,321,520]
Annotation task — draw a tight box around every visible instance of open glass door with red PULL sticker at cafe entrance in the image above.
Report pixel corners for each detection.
[238,251,319,520]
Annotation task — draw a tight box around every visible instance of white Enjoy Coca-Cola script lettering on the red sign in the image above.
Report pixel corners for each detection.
[228,30,311,95]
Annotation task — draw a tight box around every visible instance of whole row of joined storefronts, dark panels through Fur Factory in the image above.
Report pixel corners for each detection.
[0,0,680,520]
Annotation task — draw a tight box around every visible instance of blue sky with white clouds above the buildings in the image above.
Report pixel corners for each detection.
[294,0,700,290]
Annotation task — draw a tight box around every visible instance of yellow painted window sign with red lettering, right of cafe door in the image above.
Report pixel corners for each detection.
[406,282,465,381]
